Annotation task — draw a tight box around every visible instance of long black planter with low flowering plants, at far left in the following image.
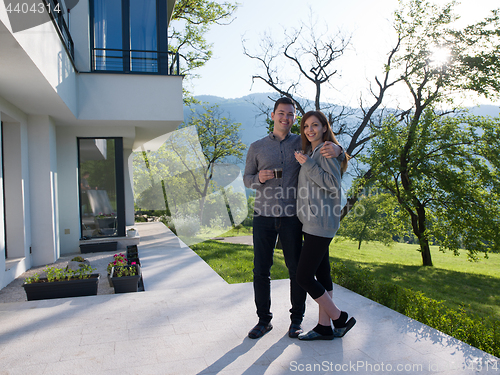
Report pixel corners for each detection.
[23,265,100,301]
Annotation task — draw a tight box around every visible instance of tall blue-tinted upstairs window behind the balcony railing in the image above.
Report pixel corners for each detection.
[90,0,168,74]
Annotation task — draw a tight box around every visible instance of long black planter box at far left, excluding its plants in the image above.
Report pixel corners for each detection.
[23,273,100,301]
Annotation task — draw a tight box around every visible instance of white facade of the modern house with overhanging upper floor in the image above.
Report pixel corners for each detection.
[0,0,183,288]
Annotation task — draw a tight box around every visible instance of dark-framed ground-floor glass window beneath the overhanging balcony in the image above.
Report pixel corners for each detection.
[78,138,125,238]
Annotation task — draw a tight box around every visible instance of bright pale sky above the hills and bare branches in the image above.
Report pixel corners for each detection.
[186,0,500,105]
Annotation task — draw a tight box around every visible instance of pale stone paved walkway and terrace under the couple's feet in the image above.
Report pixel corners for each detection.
[0,223,500,375]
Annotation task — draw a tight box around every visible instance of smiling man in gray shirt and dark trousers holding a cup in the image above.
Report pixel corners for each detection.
[243,98,342,339]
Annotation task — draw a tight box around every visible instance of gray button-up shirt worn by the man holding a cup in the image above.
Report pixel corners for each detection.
[243,133,302,217]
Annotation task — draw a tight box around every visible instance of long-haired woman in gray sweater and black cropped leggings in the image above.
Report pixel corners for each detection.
[295,111,356,340]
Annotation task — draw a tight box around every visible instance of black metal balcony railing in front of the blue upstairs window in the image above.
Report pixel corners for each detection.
[92,48,180,75]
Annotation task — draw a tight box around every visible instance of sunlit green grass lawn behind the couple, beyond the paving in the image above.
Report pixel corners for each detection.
[192,238,500,319]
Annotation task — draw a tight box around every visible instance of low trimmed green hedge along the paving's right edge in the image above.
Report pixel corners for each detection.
[332,262,500,357]
